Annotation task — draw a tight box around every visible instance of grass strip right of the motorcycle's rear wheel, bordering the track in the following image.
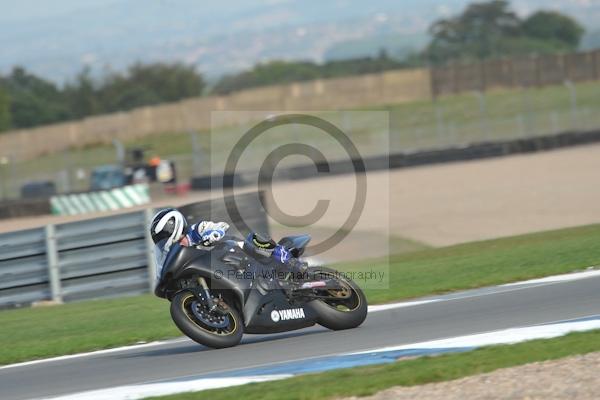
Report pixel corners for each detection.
[354,225,600,303]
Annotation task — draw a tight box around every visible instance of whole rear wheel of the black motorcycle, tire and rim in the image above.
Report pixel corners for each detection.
[311,267,368,331]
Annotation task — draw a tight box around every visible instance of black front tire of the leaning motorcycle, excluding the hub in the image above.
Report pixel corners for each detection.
[171,291,244,349]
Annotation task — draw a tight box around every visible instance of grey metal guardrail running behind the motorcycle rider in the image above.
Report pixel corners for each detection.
[0,193,268,308]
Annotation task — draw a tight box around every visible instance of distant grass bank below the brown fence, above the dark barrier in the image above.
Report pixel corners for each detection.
[6,78,600,194]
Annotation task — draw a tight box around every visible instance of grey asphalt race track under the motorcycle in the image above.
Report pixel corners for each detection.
[0,274,600,400]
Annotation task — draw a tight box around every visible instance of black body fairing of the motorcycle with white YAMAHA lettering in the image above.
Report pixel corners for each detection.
[155,237,317,333]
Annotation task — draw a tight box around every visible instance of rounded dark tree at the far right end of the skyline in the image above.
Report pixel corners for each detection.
[522,11,585,50]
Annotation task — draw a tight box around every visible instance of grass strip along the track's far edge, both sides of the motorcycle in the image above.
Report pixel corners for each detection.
[0,225,600,364]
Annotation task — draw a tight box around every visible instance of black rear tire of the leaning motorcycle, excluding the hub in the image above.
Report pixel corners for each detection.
[310,267,368,331]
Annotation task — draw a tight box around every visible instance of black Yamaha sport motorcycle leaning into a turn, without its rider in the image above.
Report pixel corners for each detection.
[154,235,367,348]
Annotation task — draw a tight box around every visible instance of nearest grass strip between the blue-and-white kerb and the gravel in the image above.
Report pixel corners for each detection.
[146,331,600,400]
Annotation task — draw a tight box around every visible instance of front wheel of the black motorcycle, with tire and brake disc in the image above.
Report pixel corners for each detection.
[171,291,244,349]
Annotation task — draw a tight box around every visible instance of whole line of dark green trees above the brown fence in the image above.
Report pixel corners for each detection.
[0,0,584,131]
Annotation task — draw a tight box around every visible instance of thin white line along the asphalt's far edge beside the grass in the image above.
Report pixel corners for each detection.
[0,269,600,370]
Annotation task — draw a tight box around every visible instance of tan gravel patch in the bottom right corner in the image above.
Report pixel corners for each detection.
[347,352,600,400]
